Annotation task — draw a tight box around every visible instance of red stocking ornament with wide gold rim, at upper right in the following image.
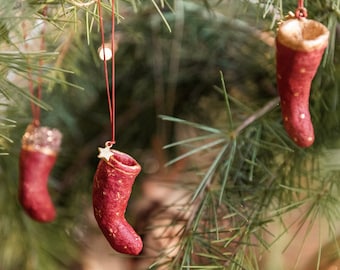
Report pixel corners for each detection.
[276,1,329,147]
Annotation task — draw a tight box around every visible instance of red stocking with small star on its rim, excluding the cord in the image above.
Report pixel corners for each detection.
[92,147,143,255]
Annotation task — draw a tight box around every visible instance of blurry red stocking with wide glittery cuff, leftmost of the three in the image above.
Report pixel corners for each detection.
[19,125,62,222]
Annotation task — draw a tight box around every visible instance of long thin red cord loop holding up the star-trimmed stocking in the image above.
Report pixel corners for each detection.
[98,0,116,146]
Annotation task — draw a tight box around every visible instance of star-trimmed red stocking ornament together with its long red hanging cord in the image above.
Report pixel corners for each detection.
[92,0,143,255]
